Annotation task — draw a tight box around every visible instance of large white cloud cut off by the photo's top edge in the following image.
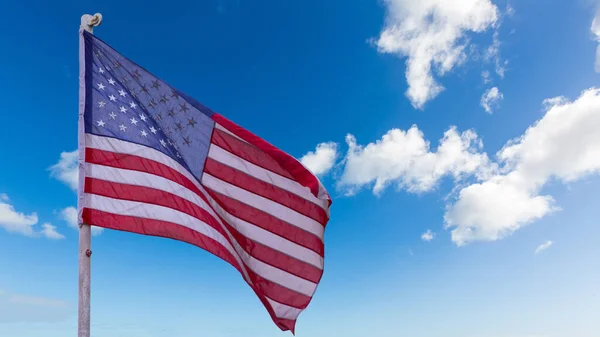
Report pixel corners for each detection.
[376,0,499,109]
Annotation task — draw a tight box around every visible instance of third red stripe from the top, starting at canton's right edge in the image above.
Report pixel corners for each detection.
[204,158,328,225]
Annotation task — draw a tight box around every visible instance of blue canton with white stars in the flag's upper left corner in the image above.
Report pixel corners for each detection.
[84,33,214,180]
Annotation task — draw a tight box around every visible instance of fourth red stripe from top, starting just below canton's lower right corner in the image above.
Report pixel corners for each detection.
[206,187,324,256]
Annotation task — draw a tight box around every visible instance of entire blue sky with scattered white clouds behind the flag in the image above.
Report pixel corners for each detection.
[0,0,600,337]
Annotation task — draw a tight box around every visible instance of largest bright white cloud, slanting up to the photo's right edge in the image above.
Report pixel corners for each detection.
[444,88,600,245]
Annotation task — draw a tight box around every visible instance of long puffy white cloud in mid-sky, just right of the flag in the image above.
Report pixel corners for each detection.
[338,125,492,195]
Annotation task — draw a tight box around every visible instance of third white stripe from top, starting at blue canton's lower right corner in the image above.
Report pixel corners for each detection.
[202,172,325,238]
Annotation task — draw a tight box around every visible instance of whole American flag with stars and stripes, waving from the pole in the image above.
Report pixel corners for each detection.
[79,31,331,333]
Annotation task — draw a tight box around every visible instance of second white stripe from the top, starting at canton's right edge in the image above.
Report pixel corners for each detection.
[208,144,329,213]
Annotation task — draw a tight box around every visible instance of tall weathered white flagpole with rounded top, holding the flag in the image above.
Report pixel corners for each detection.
[77,13,102,337]
